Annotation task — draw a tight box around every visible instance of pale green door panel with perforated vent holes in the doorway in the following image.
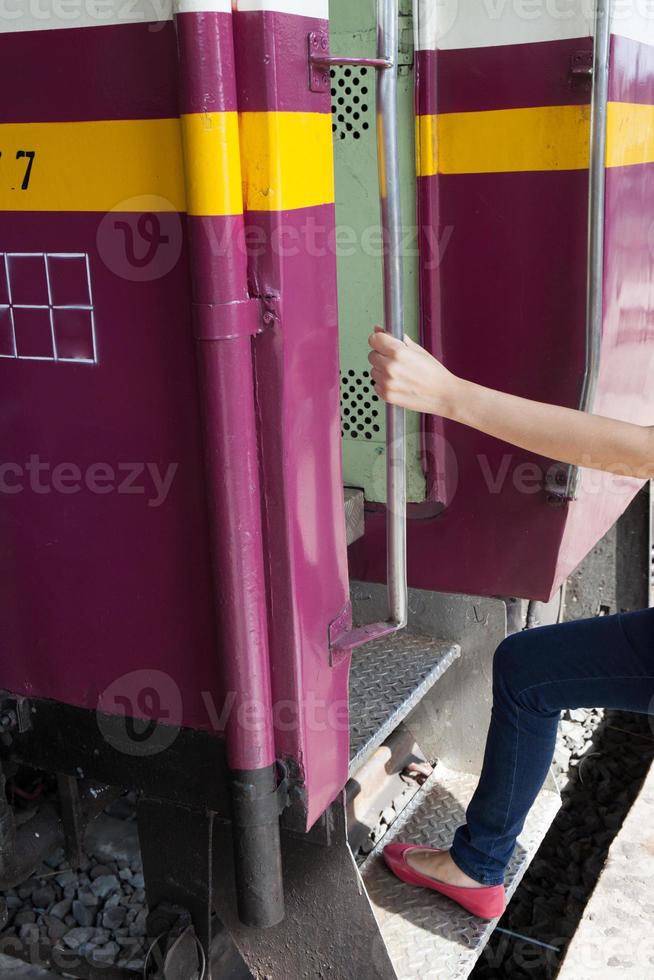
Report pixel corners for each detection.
[330,0,426,501]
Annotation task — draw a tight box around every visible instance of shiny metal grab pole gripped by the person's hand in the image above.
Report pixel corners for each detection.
[377,0,408,628]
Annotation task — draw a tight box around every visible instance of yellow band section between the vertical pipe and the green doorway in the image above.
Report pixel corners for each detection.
[240,112,334,211]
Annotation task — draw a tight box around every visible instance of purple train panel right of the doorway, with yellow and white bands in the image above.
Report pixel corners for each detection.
[352,0,654,599]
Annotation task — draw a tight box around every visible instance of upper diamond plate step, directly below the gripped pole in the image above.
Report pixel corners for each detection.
[350,630,461,776]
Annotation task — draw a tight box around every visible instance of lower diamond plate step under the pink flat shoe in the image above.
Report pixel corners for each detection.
[361,765,561,980]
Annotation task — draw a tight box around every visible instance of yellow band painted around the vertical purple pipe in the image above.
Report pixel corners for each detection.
[182,112,243,215]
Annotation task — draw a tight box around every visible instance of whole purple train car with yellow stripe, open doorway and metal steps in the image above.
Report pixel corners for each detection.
[0,0,654,980]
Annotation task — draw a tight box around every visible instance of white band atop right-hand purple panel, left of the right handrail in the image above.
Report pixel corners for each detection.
[414,0,596,50]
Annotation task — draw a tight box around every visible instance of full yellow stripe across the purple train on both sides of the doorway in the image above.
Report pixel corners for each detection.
[0,102,654,215]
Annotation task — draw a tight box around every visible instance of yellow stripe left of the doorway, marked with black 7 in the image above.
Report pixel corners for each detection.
[0,112,334,215]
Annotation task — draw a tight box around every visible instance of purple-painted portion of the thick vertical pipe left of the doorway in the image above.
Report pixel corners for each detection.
[176,12,276,771]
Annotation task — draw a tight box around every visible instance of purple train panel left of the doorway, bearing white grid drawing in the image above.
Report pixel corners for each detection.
[0,0,348,823]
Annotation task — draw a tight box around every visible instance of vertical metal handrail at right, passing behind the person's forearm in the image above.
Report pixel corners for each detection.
[566,0,612,500]
